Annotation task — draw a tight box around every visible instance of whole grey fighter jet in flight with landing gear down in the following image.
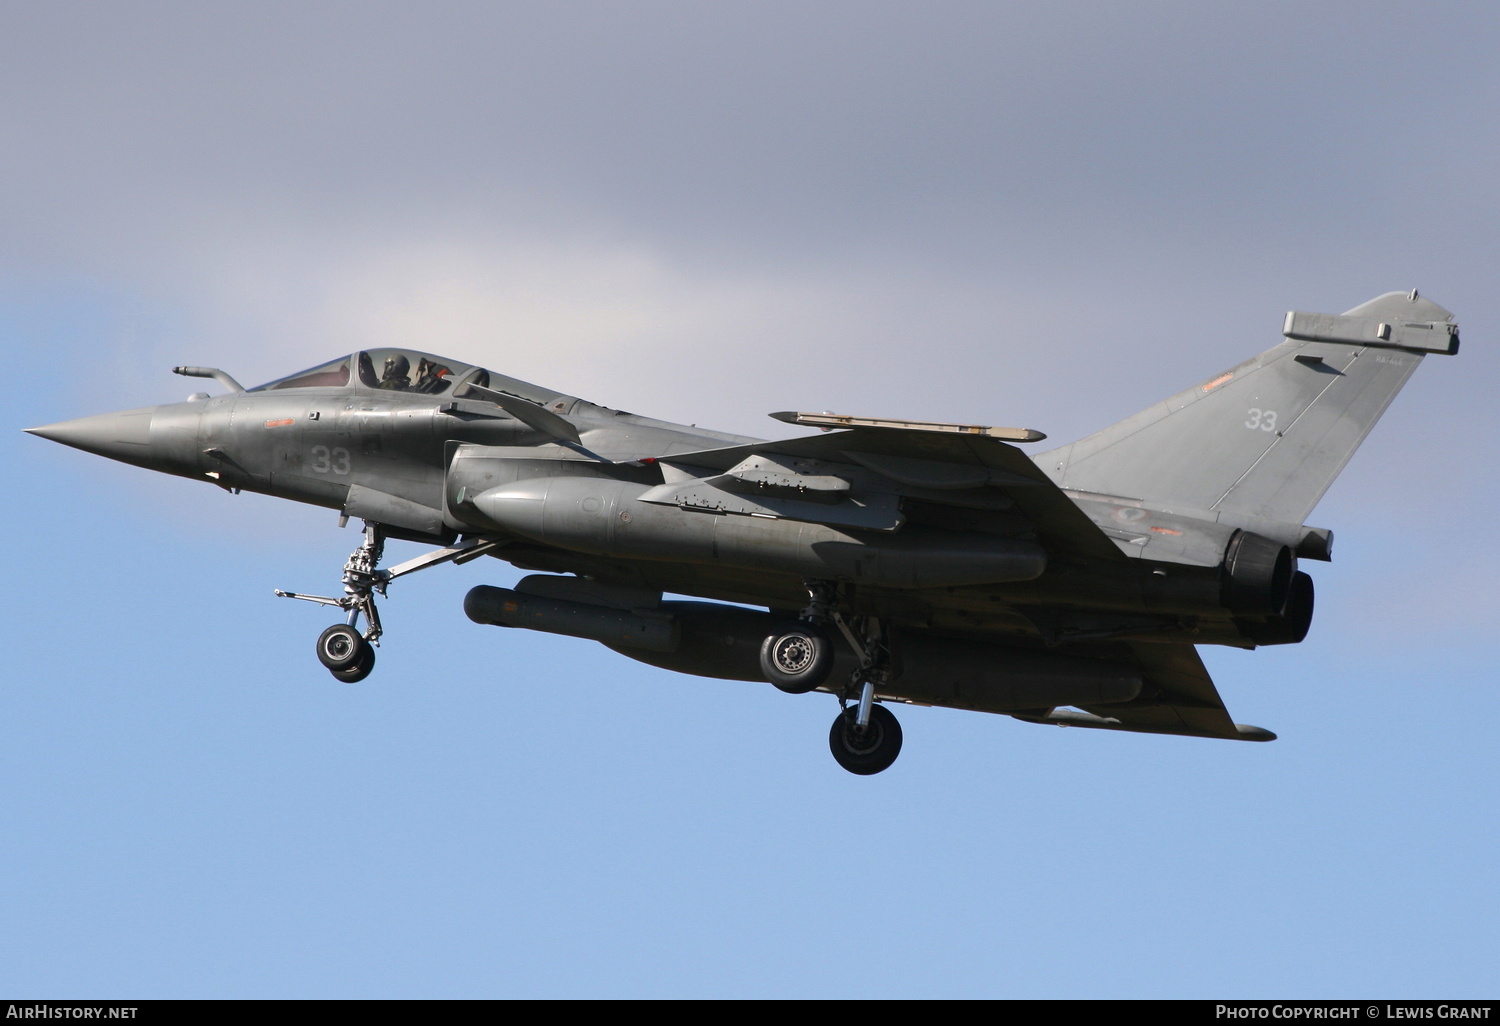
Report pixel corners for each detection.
[30,291,1458,774]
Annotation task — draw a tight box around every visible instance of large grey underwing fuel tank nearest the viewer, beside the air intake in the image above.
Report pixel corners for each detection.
[473,477,1047,588]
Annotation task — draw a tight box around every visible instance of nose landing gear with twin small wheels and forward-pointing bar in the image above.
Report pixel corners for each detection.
[276,521,500,684]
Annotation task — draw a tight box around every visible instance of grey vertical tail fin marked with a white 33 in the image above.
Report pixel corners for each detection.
[1037,290,1458,524]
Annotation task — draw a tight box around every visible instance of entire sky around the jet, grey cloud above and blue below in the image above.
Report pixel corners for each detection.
[0,0,1500,998]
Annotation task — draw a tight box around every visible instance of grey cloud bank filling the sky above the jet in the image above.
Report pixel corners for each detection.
[0,3,1500,471]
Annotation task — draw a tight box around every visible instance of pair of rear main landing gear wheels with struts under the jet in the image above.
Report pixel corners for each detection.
[761,581,902,776]
